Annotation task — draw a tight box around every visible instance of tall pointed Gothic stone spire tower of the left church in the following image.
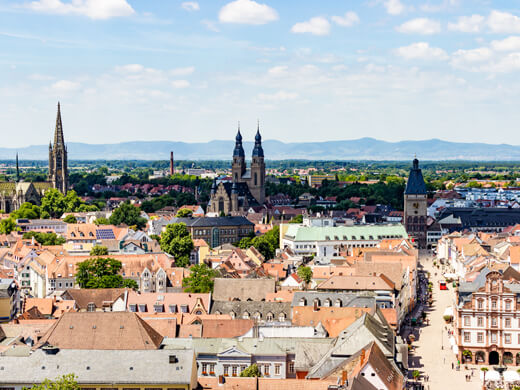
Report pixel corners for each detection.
[49,102,69,194]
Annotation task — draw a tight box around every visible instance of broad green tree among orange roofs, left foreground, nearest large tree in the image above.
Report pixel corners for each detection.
[76,257,138,289]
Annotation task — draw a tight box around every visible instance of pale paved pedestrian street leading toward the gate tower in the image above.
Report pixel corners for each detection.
[409,256,482,390]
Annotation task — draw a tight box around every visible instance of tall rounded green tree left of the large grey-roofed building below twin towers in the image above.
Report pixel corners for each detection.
[160,223,194,267]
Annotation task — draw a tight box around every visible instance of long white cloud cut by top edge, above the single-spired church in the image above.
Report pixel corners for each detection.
[26,0,135,20]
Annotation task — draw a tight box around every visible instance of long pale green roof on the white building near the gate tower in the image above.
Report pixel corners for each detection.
[285,224,408,241]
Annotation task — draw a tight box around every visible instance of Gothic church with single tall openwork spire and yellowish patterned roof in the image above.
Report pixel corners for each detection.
[0,103,69,213]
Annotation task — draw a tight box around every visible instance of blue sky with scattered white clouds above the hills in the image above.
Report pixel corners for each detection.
[0,0,520,148]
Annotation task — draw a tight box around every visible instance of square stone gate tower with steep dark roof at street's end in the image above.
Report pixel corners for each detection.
[403,158,428,249]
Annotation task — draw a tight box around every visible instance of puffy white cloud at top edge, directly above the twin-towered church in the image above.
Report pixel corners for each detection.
[218,0,278,25]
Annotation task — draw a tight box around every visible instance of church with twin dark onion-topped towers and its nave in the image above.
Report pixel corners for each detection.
[208,126,265,215]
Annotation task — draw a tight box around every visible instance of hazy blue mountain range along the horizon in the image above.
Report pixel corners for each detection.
[0,138,520,161]
